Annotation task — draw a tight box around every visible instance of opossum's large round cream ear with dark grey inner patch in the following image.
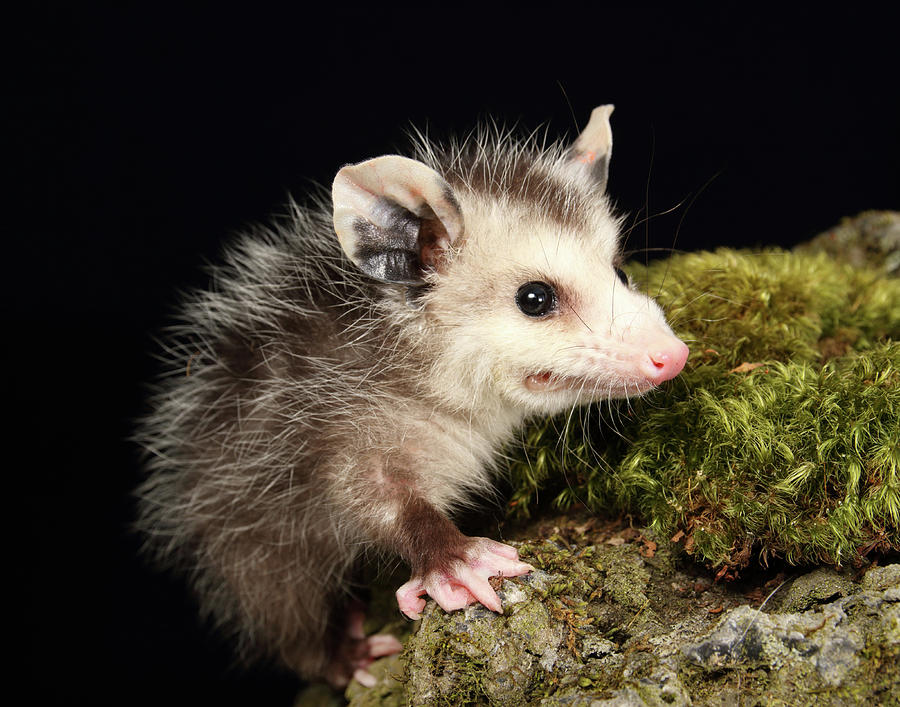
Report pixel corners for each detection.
[332,155,463,285]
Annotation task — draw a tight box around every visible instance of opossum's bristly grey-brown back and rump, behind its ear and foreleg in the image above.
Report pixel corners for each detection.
[136,198,394,672]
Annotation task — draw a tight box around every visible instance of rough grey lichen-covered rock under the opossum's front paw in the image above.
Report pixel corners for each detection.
[330,533,900,707]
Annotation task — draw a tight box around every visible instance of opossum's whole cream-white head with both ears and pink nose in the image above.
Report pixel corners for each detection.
[333,106,688,413]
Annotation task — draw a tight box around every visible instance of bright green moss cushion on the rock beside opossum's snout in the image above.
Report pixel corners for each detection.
[511,249,900,566]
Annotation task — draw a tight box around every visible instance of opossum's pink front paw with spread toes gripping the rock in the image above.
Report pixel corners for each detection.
[397,538,534,619]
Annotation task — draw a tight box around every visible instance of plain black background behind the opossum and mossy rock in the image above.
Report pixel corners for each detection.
[14,3,900,705]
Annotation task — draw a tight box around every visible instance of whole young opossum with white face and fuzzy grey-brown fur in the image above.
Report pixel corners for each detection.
[138,106,688,686]
